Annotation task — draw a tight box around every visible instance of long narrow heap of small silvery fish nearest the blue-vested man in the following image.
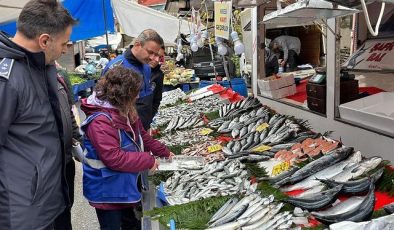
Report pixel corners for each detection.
[155,95,224,126]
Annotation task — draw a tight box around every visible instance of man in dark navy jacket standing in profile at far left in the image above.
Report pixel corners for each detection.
[0,0,76,230]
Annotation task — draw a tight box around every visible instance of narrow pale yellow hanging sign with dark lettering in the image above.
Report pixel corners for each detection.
[215,1,232,40]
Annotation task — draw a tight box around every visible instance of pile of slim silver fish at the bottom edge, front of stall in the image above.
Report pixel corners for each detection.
[208,194,293,230]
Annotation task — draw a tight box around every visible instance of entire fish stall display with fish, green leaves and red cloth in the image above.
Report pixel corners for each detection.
[145,85,394,230]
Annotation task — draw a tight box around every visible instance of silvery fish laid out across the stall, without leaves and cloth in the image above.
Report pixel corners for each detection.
[155,94,394,230]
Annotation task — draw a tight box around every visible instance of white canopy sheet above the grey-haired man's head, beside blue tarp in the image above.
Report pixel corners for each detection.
[111,0,200,44]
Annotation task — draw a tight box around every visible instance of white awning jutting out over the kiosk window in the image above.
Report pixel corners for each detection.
[263,0,359,28]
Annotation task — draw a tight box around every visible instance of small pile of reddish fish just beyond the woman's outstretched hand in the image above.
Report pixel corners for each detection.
[182,141,225,163]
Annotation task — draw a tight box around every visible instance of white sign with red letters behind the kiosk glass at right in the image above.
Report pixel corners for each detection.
[344,38,394,71]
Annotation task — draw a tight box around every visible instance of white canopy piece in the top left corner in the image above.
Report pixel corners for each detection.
[0,0,29,24]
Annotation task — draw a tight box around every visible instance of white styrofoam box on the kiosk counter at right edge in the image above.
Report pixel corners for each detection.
[339,92,394,134]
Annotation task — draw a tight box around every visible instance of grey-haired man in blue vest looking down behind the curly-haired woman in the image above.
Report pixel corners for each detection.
[101,29,164,130]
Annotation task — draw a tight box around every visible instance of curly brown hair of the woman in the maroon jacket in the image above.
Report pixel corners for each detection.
[95,66,142,117]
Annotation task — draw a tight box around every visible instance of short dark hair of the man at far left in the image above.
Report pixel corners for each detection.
[17,0,77,39]
